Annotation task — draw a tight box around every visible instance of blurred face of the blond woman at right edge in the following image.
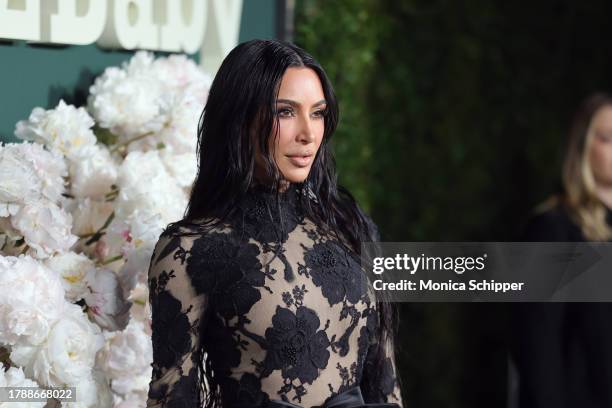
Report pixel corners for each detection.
[588,106,612,187]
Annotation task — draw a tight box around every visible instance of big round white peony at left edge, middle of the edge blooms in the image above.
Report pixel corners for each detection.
[0,255,67,345]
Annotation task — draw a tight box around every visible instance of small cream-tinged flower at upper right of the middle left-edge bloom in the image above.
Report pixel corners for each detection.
[44,252,95,302]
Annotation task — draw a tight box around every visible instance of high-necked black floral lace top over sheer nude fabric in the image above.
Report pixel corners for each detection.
[147,184,401,407]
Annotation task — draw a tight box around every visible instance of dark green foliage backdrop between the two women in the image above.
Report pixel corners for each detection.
[295,0,612,407]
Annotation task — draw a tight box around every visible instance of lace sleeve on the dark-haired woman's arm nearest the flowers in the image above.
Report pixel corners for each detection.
[147,232,208,407]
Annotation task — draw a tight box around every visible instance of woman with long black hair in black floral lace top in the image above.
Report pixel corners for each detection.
[147,40,401,407]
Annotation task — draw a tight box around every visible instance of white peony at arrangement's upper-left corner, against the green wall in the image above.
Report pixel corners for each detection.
[15,100,96,158]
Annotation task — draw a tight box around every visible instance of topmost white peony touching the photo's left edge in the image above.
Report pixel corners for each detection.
[0,143,68,217]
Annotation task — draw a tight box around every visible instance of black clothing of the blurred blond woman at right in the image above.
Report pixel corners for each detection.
[511,202,612,408]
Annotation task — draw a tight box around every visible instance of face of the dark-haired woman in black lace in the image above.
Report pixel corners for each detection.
[256,67,327,183]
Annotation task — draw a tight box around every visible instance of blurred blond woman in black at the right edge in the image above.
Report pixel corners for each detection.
[513,93,612,408]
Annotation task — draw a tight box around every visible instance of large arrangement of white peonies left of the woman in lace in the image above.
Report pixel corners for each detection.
[0,51,211,407]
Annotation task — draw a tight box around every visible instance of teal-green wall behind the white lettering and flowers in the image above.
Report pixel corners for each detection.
[0,0,276,142]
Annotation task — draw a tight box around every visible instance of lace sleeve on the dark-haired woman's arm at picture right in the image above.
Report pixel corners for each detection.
[361,334,403,407]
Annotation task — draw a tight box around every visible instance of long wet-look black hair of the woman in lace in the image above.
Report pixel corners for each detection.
[168,40,396,408]
